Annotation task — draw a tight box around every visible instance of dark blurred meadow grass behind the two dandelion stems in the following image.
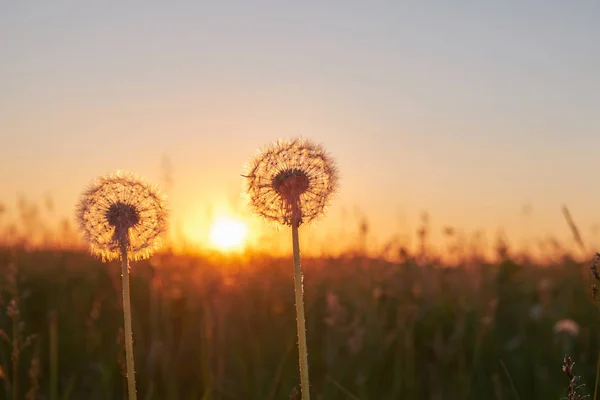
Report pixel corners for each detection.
[0,247,600,400]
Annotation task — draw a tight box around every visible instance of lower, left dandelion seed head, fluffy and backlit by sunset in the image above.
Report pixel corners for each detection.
[77,171,168,261]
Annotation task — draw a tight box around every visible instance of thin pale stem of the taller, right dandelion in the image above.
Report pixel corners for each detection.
[292,223,310,400]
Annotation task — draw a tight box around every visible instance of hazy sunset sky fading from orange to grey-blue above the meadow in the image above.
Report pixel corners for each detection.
[0,0,600,255]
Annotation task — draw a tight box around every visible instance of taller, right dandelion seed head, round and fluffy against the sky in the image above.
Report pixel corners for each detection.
[244,138,338,226]
